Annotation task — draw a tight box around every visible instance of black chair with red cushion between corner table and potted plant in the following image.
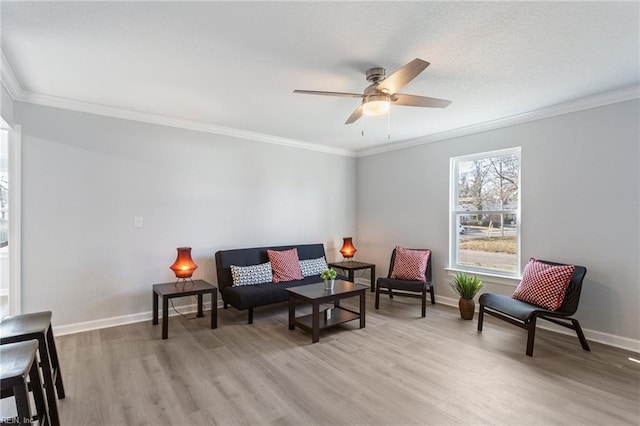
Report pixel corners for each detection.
[375,247,436,318]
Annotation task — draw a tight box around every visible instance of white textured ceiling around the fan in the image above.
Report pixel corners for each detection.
[0,0,640,151]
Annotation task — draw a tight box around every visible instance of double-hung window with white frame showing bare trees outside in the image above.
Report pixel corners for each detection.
[449,148,520,276]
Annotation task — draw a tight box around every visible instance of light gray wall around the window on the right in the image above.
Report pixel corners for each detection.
[357,100,640,342]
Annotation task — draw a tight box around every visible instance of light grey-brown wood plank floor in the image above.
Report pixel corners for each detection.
[54,293,640,425]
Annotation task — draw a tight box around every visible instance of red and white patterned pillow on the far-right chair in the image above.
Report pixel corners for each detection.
[511,258,576,311]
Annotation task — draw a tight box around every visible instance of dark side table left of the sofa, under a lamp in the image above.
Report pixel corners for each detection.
[153,280,218,339]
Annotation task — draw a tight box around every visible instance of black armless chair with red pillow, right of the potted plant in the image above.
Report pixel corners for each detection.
[478,259,591,356]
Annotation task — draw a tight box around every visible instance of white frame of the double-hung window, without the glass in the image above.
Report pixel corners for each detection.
[447,147,522,285]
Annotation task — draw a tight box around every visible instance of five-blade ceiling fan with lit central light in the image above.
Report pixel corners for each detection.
[293,58,451,124]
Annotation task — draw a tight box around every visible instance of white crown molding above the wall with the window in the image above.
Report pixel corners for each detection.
[356,86,640,158]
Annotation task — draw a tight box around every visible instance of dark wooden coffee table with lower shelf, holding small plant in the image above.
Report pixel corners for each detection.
[286,280,368,343]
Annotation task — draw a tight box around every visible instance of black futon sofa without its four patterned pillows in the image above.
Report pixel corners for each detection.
[216,244,348,324]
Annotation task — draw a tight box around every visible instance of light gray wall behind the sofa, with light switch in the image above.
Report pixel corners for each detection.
[15,102,356,325]
